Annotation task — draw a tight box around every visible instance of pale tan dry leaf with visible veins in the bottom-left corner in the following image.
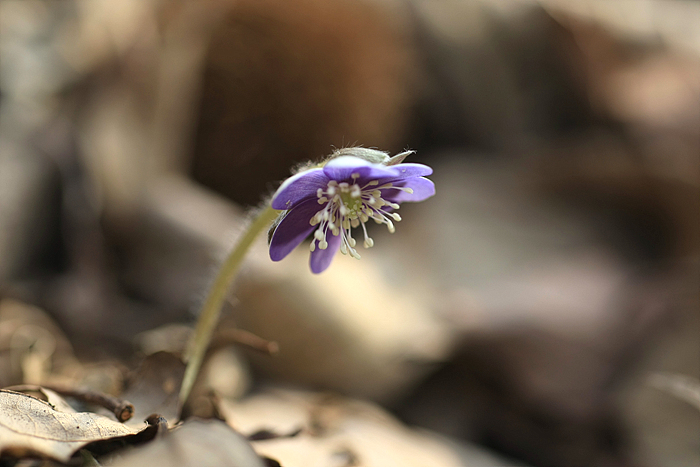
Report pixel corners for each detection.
[0,389,141,462]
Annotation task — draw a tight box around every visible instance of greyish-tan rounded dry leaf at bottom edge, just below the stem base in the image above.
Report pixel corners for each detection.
[112,420,265,467]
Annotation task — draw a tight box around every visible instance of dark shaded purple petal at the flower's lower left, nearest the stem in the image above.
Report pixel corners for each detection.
[270,198,322,261]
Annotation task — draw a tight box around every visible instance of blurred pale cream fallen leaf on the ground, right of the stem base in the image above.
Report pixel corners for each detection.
[220,389,468,467]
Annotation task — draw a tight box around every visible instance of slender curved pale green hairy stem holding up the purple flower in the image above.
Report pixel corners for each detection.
[178,206,278,408]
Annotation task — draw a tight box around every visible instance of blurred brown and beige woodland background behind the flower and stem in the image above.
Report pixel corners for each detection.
[0,0,700,467]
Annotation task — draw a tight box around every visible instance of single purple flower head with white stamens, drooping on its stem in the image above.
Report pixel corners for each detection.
[270,148,435,274]
